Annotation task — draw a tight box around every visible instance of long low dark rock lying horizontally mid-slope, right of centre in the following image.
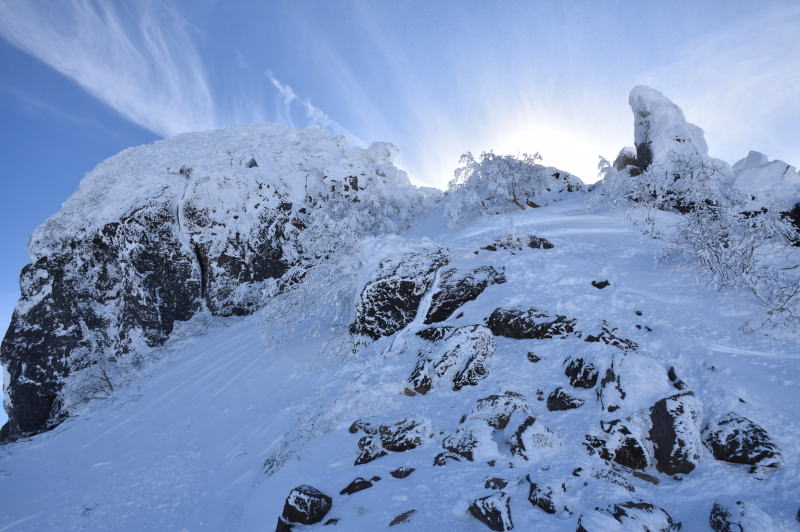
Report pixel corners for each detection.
[487,308,575,340]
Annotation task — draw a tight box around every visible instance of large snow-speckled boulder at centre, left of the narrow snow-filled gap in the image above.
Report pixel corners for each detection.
[350,249,449,340]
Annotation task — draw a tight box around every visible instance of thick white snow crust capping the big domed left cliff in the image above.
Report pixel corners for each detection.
[29,124,422,257]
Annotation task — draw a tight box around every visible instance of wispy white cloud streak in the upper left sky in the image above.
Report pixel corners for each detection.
[0,0,218,136]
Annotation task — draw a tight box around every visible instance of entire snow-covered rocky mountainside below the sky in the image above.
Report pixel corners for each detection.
[0,87,800,532]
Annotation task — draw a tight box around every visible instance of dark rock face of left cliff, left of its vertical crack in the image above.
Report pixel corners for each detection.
[0,202,201,437]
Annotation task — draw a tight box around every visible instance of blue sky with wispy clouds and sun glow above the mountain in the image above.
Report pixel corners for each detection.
[0,0,800,420]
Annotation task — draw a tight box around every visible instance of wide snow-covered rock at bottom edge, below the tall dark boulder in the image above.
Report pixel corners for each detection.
[576,501,681,532]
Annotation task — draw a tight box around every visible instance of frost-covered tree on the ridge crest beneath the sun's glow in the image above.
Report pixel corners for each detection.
[445,151,583,226]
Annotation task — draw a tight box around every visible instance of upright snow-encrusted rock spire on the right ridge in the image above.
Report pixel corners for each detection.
[628,85,708,171]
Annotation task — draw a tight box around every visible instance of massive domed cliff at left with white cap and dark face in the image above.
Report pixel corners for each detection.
[0,125,435,439]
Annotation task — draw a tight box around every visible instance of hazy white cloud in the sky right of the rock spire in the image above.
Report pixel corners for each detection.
[645,6,800,165]
